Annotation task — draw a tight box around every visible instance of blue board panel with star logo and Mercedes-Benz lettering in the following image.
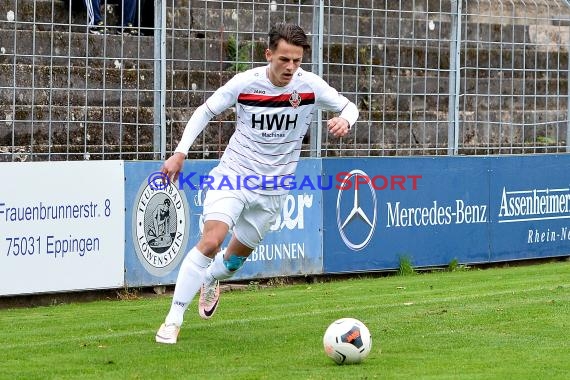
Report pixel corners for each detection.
[323,157,490,273]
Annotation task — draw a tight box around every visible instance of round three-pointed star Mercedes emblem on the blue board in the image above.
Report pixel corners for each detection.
[336,169,376,251]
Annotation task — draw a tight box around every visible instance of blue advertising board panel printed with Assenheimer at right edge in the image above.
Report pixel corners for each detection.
[488,155,570,262]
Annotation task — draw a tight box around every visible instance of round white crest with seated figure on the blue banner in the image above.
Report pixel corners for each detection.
[132,181,189,276]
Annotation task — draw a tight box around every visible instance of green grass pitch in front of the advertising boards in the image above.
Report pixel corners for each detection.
[0,262,570,380]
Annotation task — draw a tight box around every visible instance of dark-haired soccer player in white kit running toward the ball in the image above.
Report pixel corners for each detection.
[156,23,358,344]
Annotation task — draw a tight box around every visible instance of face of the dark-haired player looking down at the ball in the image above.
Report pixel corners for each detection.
[265,40,303,87]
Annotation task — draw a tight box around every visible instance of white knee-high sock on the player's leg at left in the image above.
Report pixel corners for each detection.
[164,247,212,326]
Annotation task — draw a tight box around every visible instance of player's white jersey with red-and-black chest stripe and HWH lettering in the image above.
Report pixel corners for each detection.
[173,66,357,192]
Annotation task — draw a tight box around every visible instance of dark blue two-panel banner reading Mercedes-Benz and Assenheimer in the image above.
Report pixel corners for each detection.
[323,155,570,273]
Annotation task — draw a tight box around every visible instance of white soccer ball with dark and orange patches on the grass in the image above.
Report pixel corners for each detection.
[323,318,372,364]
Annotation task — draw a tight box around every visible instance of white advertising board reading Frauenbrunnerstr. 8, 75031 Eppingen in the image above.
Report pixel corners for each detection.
[0,161,125,296]
